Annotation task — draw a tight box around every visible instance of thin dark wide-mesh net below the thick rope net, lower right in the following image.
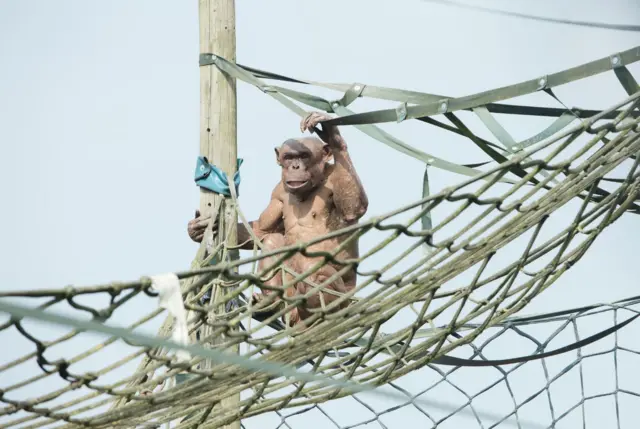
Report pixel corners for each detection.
[242,297,640,429]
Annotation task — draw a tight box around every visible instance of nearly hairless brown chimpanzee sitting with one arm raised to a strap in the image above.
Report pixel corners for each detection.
[189,113,368,325]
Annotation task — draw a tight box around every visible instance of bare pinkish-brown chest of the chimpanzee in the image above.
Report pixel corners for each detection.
[283,186,335,229]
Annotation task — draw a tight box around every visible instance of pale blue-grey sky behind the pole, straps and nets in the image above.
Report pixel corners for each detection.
[0,0,640,428]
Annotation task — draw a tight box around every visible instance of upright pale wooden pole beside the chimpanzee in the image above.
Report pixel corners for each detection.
[198,0,240,429]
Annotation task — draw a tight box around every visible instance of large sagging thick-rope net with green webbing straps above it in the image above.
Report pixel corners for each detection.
[0,48,640,428]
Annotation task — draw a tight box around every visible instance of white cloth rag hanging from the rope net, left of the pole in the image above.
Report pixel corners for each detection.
[151,273,191,362]
